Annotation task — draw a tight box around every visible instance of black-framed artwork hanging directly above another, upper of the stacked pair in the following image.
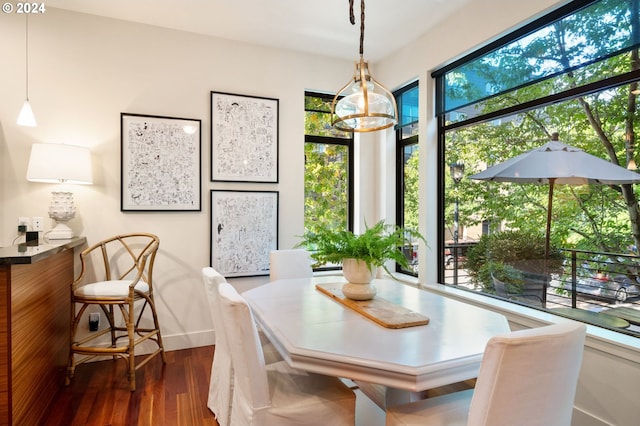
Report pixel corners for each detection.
[211,92,279,183]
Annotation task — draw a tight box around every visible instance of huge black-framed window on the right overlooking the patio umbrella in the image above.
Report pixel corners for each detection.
[433,0,640,333]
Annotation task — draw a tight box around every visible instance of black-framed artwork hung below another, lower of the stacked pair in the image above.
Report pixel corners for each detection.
[211,189,278,277]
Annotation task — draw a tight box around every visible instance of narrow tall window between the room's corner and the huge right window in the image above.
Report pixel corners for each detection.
[394,81,419,275]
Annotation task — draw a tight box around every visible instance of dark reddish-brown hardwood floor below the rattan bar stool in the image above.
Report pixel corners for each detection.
[42,346,218,426]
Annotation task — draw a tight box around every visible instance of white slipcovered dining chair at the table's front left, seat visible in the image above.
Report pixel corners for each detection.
[218,283,356,426]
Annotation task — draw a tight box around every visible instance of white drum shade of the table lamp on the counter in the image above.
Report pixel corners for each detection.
[27,143,93,184]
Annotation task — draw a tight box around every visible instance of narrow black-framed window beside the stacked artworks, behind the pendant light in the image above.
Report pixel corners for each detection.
[304,92,353,240]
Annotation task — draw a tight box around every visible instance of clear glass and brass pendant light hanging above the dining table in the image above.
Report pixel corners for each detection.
[331,0,398,132]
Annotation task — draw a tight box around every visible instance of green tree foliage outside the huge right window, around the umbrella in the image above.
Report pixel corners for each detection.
[445,19,640,252]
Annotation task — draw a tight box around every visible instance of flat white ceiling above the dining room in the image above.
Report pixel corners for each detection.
[46,0,473,62]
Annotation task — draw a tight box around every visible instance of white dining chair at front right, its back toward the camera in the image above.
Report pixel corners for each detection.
[386,322,586,426]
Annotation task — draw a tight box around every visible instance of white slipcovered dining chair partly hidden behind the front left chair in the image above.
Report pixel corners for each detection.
[202,266,282,426]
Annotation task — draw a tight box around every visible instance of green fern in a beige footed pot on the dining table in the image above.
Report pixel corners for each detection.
[297,221,426,300]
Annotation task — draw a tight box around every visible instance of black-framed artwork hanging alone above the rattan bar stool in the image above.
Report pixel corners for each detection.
[120,113,202,211]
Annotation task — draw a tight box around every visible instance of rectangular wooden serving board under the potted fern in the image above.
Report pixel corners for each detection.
[316,283,429,328]
